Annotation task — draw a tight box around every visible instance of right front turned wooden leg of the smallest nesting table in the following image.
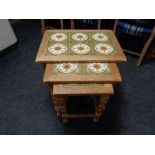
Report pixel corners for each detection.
[94,96,109,122]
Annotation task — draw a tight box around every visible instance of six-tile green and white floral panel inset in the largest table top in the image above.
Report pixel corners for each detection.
[46,32,116,56]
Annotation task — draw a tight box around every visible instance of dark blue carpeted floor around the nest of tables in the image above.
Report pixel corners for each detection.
[0,20,155,135]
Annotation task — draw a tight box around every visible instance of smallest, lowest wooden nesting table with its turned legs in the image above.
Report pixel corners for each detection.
[52,84,113,122]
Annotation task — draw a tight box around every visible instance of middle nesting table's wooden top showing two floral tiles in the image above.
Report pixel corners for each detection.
[43,63,122,84]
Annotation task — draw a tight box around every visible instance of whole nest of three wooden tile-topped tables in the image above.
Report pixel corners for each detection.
[36,30,126,122]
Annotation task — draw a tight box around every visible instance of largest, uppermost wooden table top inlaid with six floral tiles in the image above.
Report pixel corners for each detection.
[36,30,126,63]
